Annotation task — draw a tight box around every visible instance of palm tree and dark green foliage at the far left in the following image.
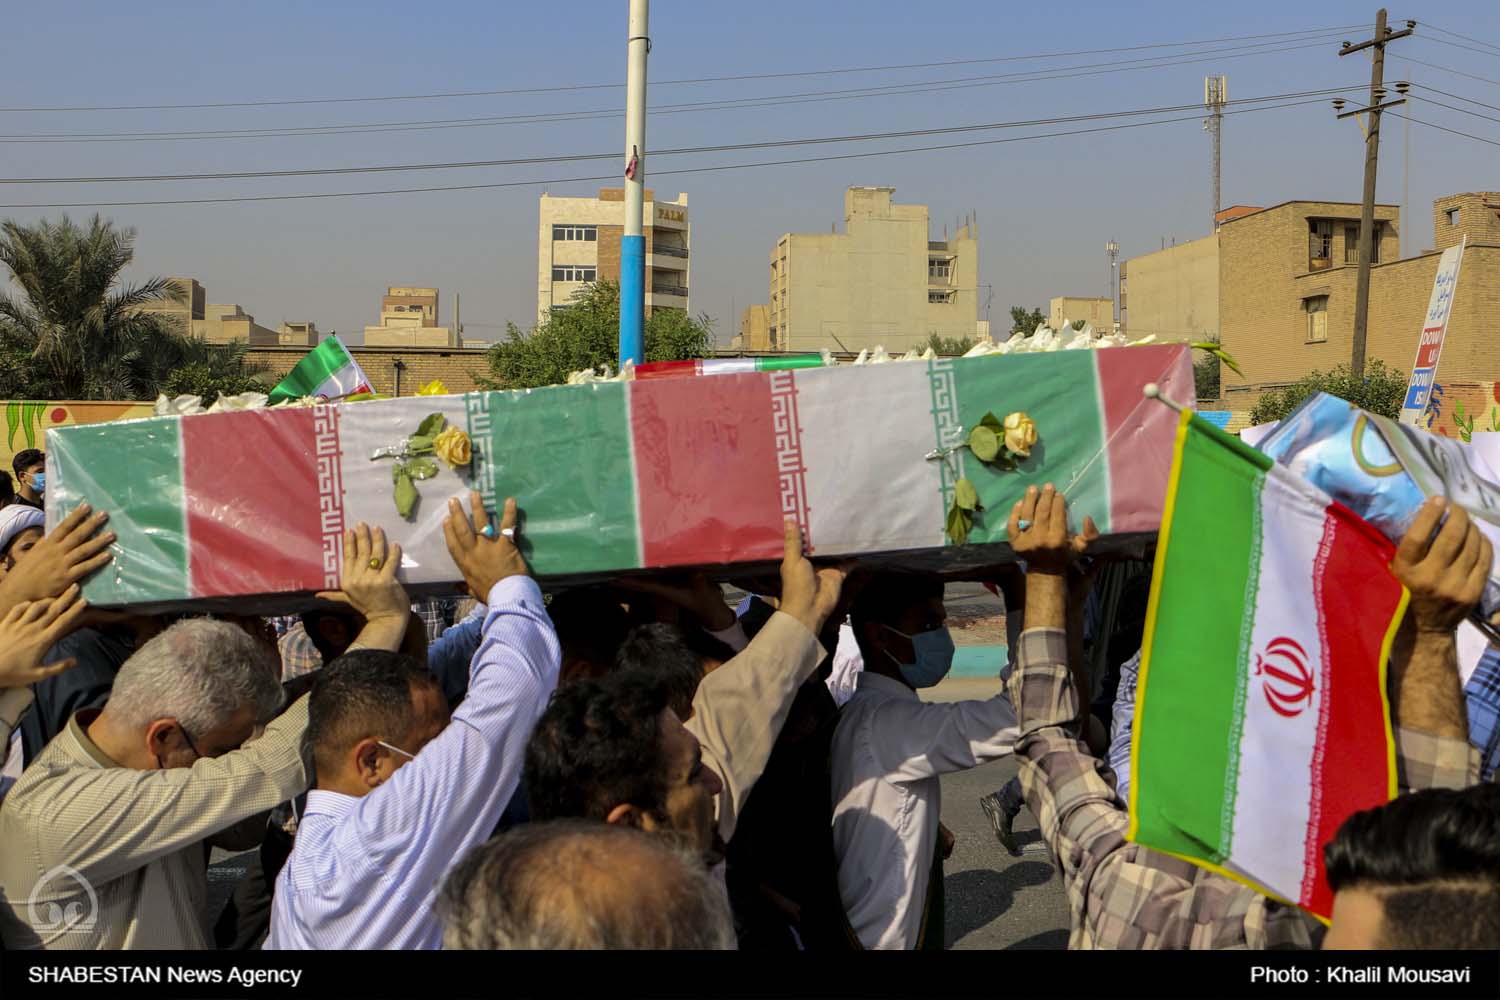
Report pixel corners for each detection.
[0,216,266,402]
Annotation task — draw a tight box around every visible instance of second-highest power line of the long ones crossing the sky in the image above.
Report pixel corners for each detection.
[0,42,1323,142]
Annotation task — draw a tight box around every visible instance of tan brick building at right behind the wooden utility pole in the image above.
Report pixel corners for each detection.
[1121,192,1500,406]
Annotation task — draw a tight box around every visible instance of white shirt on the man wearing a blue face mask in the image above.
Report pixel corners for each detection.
[833,670,1017,949]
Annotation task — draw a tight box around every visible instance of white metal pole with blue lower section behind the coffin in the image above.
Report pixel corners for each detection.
[620,0,651,367]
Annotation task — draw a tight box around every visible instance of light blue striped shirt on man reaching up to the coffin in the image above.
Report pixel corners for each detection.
[266,577,561,949]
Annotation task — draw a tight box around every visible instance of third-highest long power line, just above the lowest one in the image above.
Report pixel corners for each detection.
[0,87,1355,184]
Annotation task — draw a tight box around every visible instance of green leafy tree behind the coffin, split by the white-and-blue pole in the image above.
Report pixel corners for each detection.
[479,282,714,388]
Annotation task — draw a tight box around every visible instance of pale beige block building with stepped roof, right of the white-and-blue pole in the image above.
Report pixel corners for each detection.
[768,187,980,351]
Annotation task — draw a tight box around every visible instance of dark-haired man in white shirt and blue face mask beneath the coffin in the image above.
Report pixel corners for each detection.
[833,574,1017,949]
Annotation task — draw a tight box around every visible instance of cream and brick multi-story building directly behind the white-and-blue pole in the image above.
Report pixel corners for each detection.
[537,187,693,324]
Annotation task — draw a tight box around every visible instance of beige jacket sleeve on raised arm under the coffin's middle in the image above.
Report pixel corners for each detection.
[687,612,827,843]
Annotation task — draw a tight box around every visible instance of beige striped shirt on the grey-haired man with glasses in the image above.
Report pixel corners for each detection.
[0,699,308,949]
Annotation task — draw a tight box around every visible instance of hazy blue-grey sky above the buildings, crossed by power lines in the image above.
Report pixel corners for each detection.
[0,0,1500,340]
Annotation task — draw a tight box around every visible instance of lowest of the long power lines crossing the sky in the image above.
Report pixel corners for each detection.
[0,97,1323,208]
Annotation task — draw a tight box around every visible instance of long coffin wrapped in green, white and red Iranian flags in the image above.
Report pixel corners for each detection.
[47,345,1193,613]
